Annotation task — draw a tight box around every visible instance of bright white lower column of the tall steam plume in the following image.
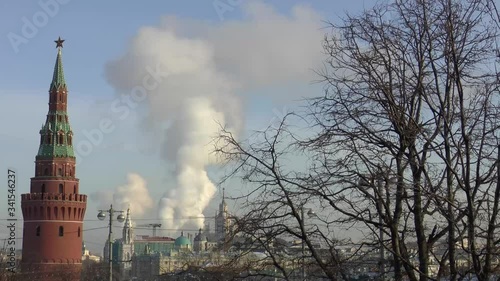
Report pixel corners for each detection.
[159,97,224,228]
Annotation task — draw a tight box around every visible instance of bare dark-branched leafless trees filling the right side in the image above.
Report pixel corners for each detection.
[215,0,500,281]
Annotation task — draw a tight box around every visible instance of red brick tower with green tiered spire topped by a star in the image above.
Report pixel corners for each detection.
[21,38,87,281]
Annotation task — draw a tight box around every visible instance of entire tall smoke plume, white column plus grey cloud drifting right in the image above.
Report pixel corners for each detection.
[106,3,323,232]
